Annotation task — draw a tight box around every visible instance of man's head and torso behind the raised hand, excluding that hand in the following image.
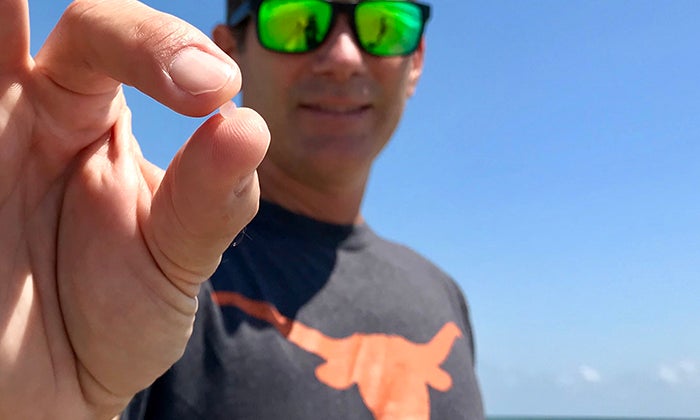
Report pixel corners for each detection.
[125,0,480,419]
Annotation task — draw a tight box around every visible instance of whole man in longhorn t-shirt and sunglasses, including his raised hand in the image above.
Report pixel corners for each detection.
[0,0,483,419]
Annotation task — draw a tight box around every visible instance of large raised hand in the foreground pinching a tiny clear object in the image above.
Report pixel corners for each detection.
[0,0,269,419]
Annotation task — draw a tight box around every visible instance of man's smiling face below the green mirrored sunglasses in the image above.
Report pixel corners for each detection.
[215,2,424,187]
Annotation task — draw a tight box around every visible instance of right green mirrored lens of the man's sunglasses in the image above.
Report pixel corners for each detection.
[355,1,423,56]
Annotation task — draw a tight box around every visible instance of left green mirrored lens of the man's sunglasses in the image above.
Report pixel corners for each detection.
[258,0,333,53]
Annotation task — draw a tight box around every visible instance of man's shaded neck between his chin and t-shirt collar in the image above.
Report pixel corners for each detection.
[258,161,368,225]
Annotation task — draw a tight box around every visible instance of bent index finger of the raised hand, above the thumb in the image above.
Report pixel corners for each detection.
[35,0,240,116]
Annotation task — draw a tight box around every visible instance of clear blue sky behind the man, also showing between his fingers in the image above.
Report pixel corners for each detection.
[30,0,700,417]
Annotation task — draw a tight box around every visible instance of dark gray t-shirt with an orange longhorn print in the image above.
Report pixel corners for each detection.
[122,202,484,420]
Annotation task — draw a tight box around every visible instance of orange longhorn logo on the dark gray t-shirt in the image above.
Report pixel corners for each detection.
[212,292,462,420]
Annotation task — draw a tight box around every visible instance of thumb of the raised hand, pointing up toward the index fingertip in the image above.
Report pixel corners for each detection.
[144,103,270,297]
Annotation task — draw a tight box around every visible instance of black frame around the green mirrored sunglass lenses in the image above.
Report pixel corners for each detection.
[226,0,430,57]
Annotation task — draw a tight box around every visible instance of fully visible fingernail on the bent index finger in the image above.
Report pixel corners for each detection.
[168,48,234,95]
